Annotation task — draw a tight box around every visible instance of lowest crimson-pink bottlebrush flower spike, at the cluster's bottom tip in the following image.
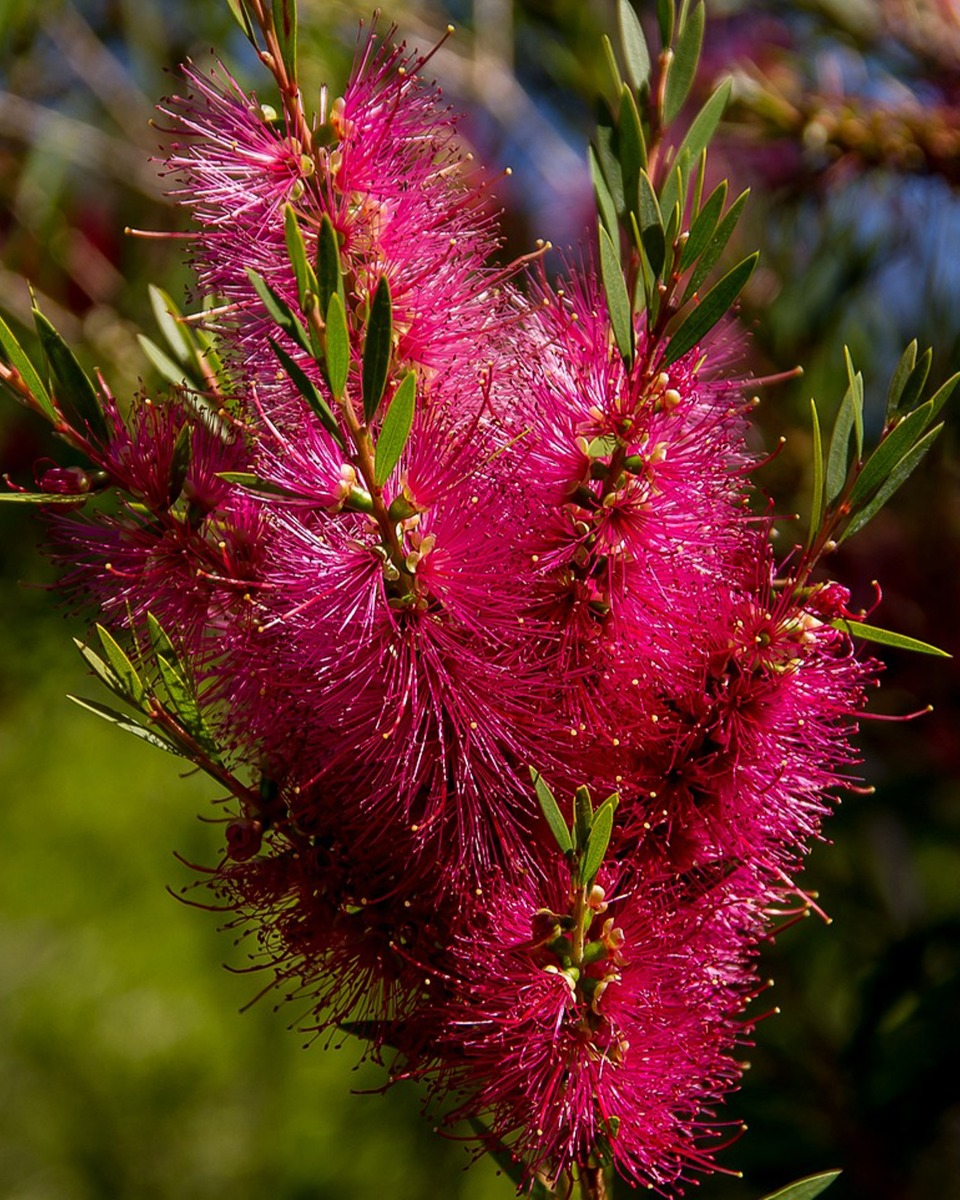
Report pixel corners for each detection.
[430,864,760,1192]
